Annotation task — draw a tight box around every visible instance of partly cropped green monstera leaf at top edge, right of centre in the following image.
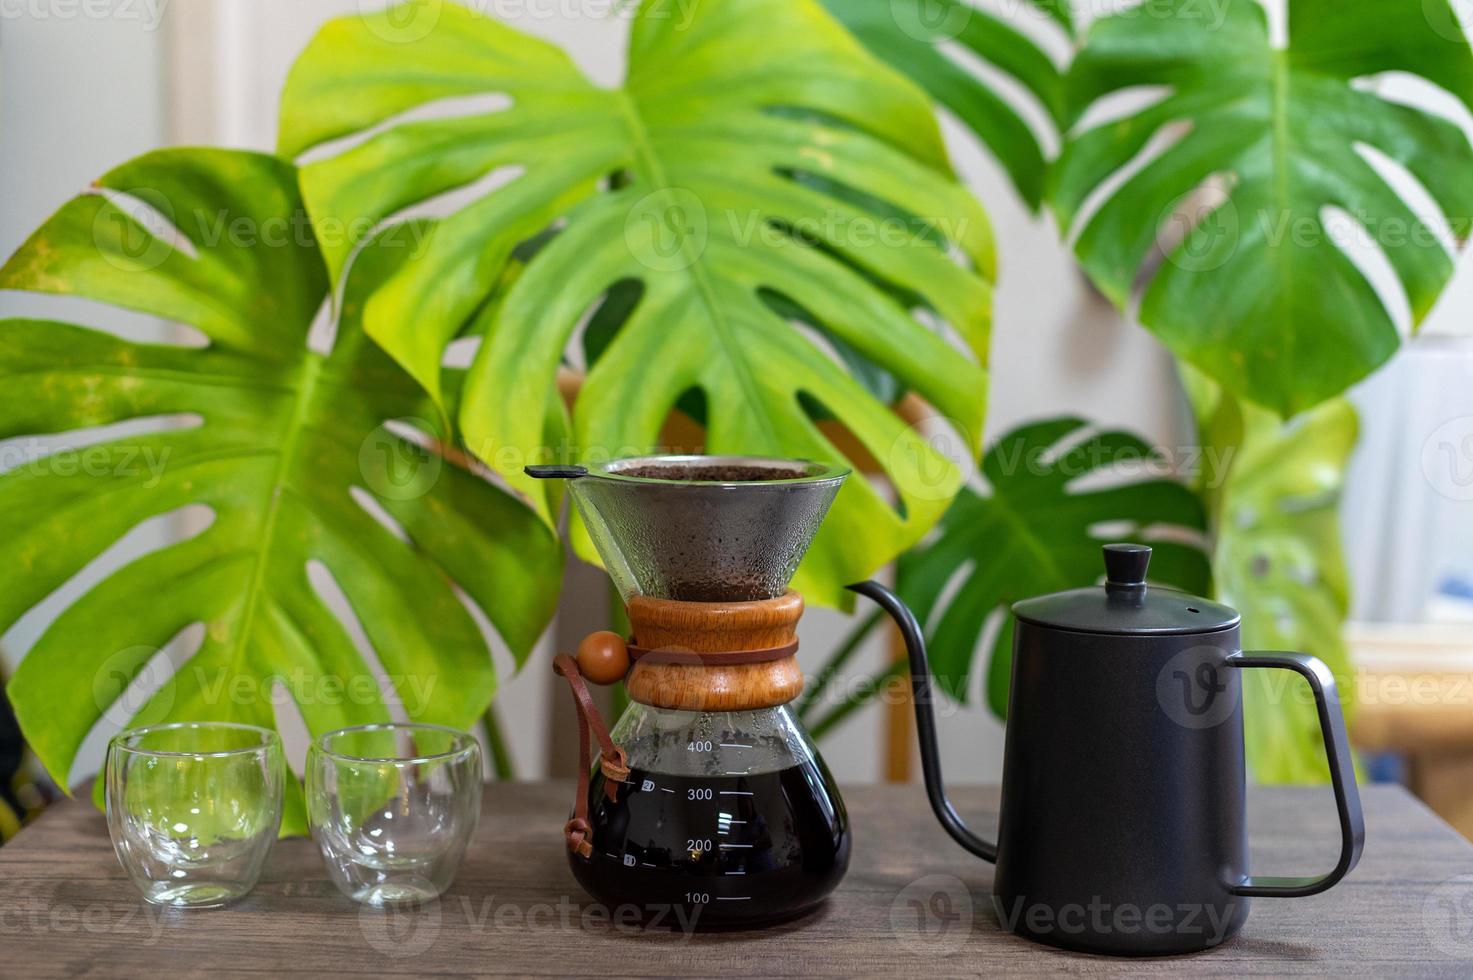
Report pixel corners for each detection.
[823,0,1074,209]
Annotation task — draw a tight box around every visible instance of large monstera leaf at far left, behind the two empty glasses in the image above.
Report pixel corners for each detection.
[0,150,561,831]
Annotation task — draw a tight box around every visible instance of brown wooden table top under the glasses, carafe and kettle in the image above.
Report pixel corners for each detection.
[0,784,1473,979]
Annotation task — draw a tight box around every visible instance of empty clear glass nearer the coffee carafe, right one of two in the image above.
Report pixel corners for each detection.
[306,725,482,905]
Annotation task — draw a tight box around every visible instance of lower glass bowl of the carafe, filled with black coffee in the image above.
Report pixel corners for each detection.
[572,704,850,924]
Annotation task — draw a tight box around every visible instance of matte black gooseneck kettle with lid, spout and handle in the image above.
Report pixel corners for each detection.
[851,544,1365,955]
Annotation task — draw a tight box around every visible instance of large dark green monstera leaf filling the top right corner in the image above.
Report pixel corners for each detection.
[1050,0,1473,416]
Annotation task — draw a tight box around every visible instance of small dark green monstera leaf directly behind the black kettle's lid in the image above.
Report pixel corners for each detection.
[896,419,1211,718]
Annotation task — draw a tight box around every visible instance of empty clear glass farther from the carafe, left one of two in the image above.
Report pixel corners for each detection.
[105,722,286,908]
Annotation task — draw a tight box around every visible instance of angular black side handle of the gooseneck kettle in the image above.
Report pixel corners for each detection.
[1227,651,1365,899]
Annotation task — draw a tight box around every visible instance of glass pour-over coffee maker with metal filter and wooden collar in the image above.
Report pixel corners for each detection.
[527,457,850,925]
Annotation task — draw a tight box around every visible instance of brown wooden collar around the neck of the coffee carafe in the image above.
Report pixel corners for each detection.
[625,588,803,712]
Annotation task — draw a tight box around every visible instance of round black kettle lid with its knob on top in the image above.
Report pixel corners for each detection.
[1013,544,1239,635]
